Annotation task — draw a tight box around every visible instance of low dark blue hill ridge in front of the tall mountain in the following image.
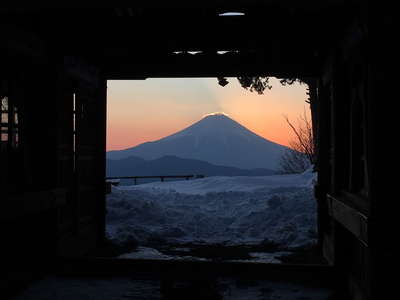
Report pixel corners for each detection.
[107,155,274,177]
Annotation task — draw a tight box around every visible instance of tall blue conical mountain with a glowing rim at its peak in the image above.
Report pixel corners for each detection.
[107,113,286,170]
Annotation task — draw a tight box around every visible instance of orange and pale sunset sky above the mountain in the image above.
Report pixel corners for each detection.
[107,78,309,151]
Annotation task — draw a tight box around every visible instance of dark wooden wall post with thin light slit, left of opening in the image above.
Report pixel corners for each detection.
[58,58,107,256]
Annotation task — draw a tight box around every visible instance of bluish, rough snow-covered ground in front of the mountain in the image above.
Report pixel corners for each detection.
[107,170,316,258]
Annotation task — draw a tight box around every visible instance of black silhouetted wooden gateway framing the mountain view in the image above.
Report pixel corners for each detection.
[0,0,388,299]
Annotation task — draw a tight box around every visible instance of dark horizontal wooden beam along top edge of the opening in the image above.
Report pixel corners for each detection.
[104,53,320,80]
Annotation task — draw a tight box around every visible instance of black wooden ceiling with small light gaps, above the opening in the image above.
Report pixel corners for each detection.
[0,0,359,79]
